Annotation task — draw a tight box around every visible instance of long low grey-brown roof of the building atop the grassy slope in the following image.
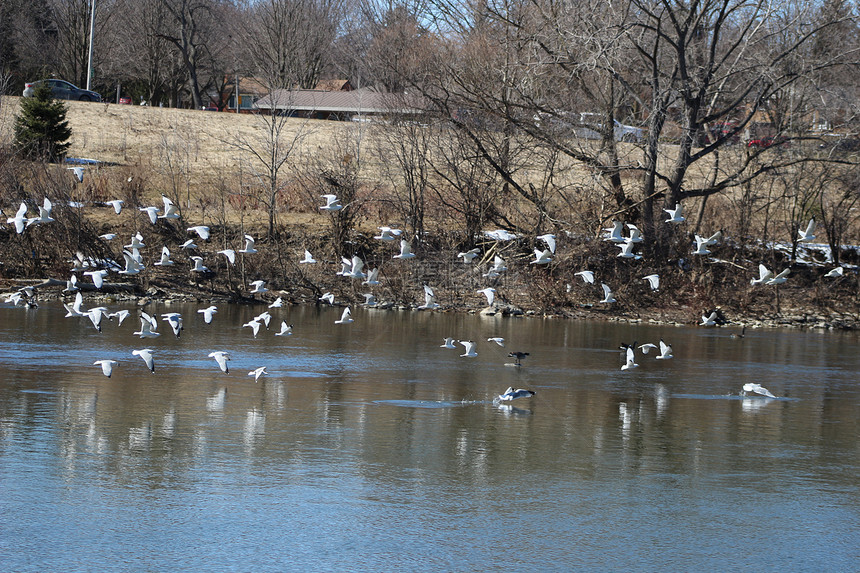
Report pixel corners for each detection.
[254,88,426,113]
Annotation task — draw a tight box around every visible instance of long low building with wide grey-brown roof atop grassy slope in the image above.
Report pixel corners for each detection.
[254,88,427,121]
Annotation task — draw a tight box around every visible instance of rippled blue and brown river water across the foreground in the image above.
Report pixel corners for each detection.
[0,303,860,572]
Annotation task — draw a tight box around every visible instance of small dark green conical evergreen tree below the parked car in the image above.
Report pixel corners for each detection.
[15,82,72,161]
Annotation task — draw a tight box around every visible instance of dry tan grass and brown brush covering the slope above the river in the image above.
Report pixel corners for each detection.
[0,98,860,324]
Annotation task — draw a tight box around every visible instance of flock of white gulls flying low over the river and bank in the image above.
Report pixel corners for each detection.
[5,177,844,402]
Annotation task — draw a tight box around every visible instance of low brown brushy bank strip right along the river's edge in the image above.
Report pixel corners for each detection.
[0,222,860,332]
